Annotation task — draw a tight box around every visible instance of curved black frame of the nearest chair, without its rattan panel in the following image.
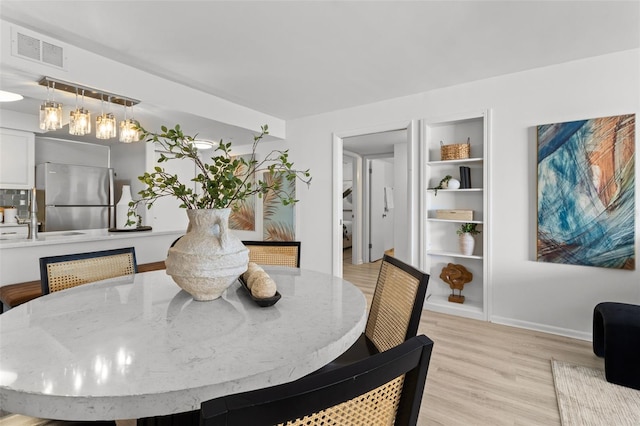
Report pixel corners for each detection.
[200,335,433,426]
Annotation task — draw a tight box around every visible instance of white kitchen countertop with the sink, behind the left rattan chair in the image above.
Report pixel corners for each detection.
[0,229,184,250]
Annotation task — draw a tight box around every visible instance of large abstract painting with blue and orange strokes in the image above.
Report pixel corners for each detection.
[537,114,636,270]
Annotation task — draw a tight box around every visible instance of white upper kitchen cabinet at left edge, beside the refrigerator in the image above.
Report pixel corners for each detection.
[0,128,35,189]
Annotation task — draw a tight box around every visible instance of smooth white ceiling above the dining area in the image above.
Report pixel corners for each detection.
[0,0,640,150]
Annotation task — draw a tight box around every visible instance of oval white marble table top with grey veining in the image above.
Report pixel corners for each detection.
[0,267,366,420]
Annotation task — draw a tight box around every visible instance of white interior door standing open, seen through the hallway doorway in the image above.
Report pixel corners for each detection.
[369,160,389,262]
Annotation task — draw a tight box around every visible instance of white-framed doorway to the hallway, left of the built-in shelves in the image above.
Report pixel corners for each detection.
[333,121,418,277]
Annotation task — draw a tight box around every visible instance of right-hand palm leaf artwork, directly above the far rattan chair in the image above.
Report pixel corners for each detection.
[262,173,296,241]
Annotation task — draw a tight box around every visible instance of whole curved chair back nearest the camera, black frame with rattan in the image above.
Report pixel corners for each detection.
[200,335,433,426]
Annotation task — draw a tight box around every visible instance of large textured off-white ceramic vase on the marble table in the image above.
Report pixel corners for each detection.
[165,209,249,301]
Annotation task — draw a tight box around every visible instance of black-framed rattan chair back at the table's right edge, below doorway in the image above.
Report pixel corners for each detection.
[365,255,429,351]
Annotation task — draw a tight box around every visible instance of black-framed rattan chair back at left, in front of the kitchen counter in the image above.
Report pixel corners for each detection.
[40,247,138,294]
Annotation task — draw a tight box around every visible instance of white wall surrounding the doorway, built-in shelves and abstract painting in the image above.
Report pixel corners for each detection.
[287,49,640,339]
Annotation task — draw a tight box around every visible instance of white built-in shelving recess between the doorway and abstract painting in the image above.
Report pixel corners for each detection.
[420,111,491,320]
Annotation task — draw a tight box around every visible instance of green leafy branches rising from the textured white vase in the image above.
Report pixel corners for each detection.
[127,124,311,225]
